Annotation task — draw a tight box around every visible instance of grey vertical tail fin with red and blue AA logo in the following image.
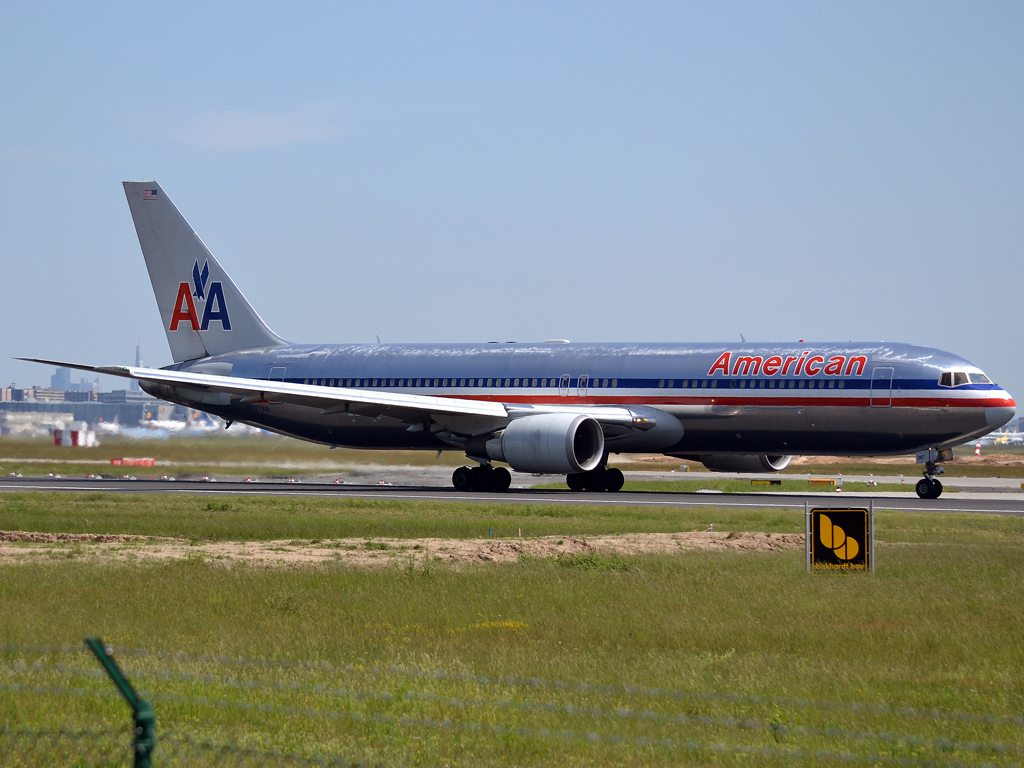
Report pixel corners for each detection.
[124,181,286,362]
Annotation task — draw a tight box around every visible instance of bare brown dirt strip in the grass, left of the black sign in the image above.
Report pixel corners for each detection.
[0,530,804,567]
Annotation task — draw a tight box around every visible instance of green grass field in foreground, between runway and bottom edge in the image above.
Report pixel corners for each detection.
[0,494,1024,766]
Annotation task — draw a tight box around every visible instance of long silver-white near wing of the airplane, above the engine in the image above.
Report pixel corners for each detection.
[17,357,648,433]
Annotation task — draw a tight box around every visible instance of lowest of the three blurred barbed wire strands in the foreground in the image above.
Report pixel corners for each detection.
[0,683,1007,768]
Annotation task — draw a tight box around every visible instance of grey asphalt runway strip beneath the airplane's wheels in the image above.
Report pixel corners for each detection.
[0,477,1024,517]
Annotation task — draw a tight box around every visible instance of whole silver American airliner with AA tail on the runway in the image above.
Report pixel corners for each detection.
[19,181,1016,499]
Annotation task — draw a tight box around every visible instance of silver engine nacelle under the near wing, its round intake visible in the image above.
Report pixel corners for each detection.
[477,414,604,474]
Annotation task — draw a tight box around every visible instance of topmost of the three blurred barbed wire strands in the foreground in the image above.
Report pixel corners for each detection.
[6,645,1024,726]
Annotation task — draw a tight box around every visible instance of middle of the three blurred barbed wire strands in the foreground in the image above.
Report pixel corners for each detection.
[8,663,1024,765]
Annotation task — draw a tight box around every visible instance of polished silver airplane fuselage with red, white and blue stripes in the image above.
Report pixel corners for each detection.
[142,343,1015,455]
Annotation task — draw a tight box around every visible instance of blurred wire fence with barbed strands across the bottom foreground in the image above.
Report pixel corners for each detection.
[0,646,1024,767]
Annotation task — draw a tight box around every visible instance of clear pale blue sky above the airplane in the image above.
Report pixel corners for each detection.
[0,2,1024,397]
